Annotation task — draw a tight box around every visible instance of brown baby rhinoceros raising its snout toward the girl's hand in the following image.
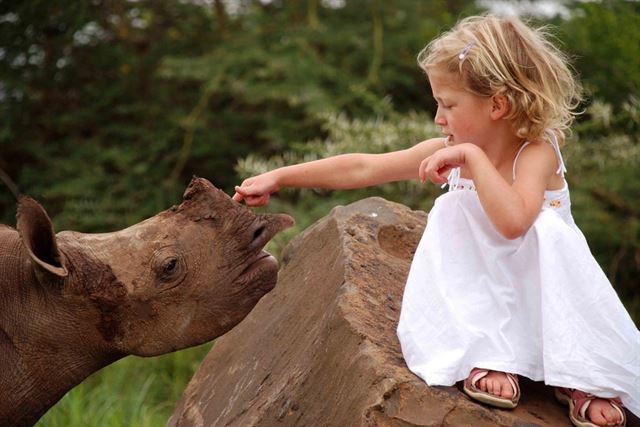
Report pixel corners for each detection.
[0,178,293,426]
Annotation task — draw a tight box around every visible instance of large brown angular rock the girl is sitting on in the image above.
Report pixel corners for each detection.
[168,198,637,427]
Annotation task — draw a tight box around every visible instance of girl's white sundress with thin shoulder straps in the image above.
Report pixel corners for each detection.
[398,137,640,415]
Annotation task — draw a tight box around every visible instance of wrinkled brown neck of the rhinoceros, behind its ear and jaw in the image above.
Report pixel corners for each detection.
[0,228,122,426]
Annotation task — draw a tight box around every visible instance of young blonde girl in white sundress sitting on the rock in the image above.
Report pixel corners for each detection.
[234,15,640,427]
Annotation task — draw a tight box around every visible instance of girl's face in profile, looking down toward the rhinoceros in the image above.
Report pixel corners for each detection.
[429,70,493,147]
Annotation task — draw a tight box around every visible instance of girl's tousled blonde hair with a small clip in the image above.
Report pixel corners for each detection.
[418,15,582,144]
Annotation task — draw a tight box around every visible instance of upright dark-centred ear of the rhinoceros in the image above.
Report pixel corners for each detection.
[16,196,69,277]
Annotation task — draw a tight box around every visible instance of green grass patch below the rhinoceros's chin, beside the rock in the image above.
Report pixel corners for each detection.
[36,343,213,427]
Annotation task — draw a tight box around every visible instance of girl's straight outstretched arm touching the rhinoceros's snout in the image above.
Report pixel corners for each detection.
[233,138,444,206]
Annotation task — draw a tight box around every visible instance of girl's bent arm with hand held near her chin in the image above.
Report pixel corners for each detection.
[420,142,557,239]
